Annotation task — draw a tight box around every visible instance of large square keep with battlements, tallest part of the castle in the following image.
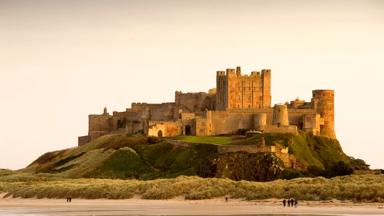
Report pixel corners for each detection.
[216,67,271,110]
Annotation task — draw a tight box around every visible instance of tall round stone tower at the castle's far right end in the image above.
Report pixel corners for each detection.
[312,89,336,139]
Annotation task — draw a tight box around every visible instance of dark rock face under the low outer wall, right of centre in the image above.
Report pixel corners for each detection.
[216,152,284,181]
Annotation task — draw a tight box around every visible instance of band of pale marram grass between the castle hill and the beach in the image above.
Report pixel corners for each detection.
[0,175,384,202]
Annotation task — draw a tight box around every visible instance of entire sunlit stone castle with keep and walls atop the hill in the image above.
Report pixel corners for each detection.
[78,67,336,145]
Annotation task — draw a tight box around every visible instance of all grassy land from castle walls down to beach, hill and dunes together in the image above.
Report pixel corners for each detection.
[0,134,378,202]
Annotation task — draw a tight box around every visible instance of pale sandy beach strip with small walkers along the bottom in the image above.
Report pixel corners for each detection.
[0,196,384,215]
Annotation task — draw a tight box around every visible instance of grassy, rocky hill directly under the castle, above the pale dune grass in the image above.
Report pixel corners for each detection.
[18,134,356,181]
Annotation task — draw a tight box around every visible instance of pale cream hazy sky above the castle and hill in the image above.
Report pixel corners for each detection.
[0,0,384,169]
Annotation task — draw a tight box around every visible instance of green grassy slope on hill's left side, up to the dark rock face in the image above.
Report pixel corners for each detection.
[23,134,217,179]
